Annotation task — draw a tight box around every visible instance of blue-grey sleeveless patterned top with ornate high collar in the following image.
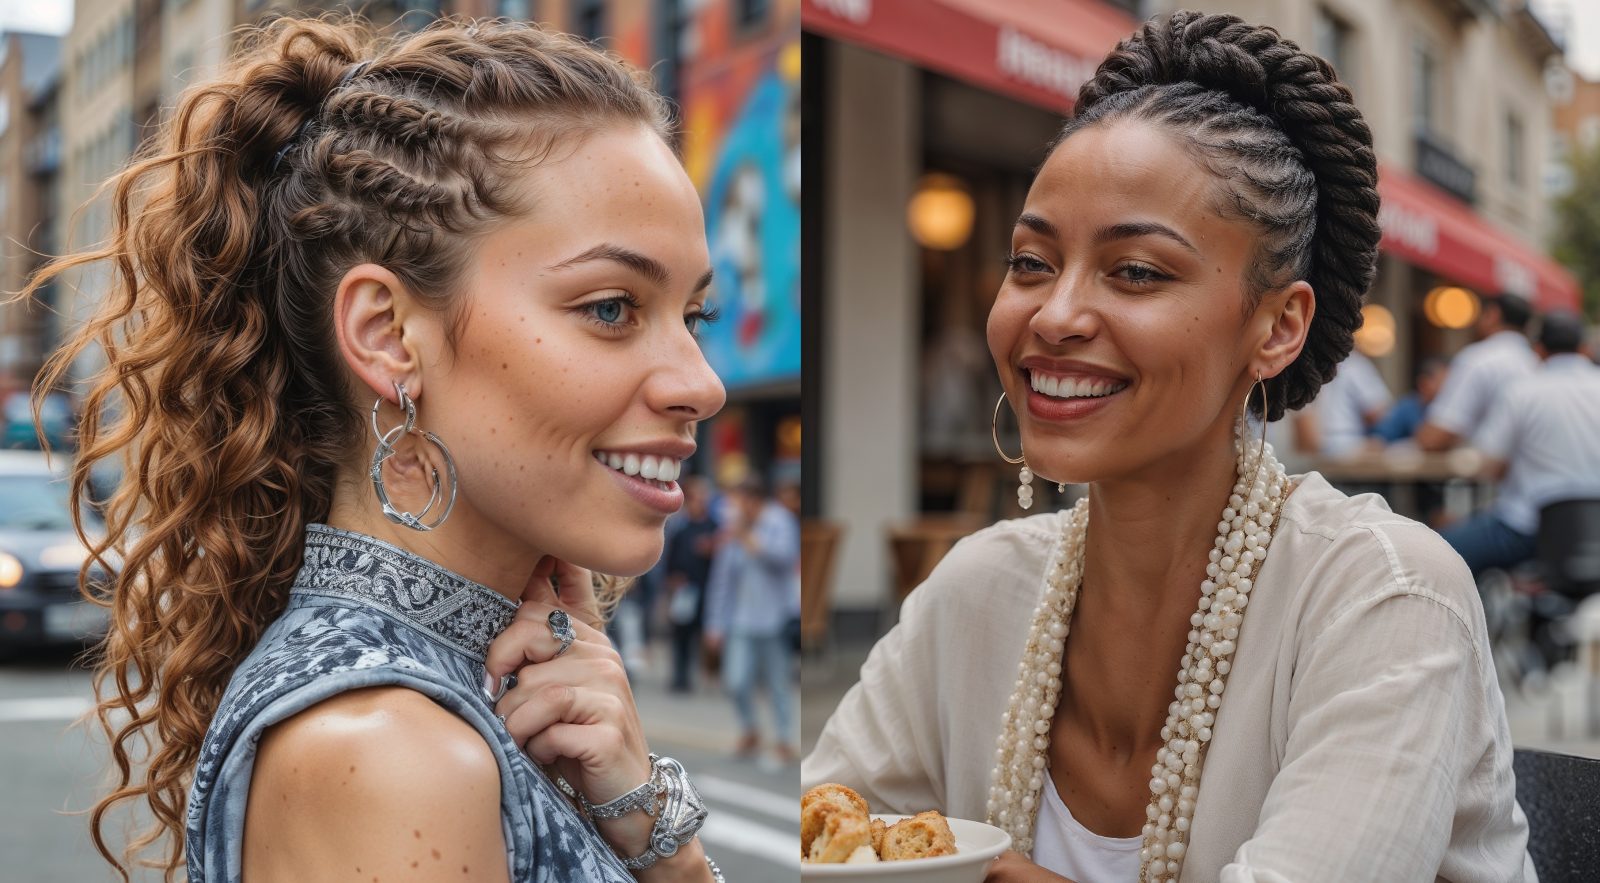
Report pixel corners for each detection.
[186,525,634,883]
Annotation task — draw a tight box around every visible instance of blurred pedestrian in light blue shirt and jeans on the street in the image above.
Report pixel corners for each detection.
[706,475,800,763]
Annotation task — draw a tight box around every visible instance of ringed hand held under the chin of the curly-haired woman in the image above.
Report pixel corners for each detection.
[485,558,654,856]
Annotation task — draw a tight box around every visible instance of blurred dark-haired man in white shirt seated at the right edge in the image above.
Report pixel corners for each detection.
[1442,314,1600,576]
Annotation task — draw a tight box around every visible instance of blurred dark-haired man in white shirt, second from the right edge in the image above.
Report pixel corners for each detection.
[1416,294,1539,451]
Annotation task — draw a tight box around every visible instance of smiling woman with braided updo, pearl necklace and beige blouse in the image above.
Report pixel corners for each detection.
[802,11,1533,883]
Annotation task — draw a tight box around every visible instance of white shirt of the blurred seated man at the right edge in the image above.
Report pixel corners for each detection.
[1477,354,1600,534]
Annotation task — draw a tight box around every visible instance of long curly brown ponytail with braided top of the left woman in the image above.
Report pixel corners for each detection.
[24,18,669,880]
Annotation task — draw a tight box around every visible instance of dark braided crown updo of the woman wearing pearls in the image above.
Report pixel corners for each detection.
[1056,11,1381,421]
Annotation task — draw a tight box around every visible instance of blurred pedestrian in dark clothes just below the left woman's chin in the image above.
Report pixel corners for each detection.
[662,475,717,693]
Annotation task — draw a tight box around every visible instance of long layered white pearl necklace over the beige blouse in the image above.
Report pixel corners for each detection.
[989,435,1288,883]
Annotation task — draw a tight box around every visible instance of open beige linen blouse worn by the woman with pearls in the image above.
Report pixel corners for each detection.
[802,473,1536,883]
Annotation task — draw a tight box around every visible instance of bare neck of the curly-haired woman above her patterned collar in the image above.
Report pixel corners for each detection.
[328,473,542,601]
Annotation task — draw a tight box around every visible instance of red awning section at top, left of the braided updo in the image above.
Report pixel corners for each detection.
[802,0,1138,110]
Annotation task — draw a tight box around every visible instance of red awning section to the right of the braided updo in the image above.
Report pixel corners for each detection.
[1378,163,1579,310]
